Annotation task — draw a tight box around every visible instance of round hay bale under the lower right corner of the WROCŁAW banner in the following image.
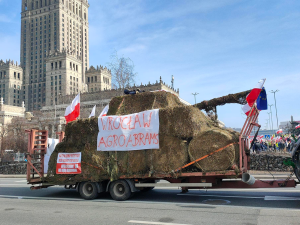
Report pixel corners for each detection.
[146,135,188,173]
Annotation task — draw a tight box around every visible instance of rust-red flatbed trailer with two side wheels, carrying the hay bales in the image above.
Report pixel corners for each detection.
[26,104,299,201]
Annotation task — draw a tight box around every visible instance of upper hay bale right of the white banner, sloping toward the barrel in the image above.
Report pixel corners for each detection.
[159,106,214,139]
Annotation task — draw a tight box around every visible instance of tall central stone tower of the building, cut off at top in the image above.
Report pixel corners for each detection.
[21,0,89,111]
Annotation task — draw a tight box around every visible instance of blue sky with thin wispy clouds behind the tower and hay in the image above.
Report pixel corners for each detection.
[0,0,300,129]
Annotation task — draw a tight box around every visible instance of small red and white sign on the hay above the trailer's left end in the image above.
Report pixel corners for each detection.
[56,152,81,174]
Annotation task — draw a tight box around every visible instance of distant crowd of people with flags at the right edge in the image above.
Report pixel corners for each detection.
[251,134,300,154]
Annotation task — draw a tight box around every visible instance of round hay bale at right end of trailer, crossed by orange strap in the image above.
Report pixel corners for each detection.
[188,129,236,172]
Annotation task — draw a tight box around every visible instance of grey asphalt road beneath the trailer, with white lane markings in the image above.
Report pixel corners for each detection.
[0,178,300,225]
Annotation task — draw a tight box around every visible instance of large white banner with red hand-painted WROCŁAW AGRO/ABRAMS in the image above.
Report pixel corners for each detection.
[97,109,159,151]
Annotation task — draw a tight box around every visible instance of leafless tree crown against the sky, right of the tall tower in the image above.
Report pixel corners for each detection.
[108,51,137,89]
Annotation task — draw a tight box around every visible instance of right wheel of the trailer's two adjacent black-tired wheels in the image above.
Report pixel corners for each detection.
[109,180,131,201]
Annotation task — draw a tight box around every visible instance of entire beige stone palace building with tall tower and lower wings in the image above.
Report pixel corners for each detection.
[0,0,179,130]
